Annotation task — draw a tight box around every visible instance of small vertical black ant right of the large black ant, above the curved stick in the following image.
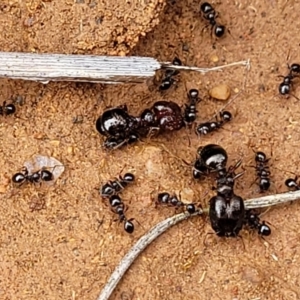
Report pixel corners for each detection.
[255,151,271,193]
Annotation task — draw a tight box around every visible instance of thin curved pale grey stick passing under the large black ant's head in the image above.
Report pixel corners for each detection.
[97,191,300,300]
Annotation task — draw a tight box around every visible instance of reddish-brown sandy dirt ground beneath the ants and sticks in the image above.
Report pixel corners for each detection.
[0,0,300,300]
